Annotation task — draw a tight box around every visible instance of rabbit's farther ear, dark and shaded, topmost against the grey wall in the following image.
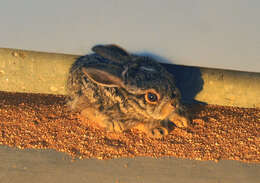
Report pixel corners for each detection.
[92,44,130,64]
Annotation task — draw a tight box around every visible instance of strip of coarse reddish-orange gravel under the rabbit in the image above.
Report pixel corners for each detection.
[0,92,260,162]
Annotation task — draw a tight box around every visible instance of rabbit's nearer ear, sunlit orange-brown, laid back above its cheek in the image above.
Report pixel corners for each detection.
[82,65,124,87]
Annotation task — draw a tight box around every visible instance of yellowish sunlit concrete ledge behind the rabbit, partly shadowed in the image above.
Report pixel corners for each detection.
[0,48,260,108]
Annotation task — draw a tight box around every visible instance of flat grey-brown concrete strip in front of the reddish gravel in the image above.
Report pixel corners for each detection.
[0,146,260,183]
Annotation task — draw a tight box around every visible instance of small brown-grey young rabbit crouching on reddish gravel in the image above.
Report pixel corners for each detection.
[67,44,189,138]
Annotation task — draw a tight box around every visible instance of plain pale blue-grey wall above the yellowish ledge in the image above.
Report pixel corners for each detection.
[0,0,260,72]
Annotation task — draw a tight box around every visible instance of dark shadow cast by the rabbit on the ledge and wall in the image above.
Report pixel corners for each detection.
[138,52,206,104]
